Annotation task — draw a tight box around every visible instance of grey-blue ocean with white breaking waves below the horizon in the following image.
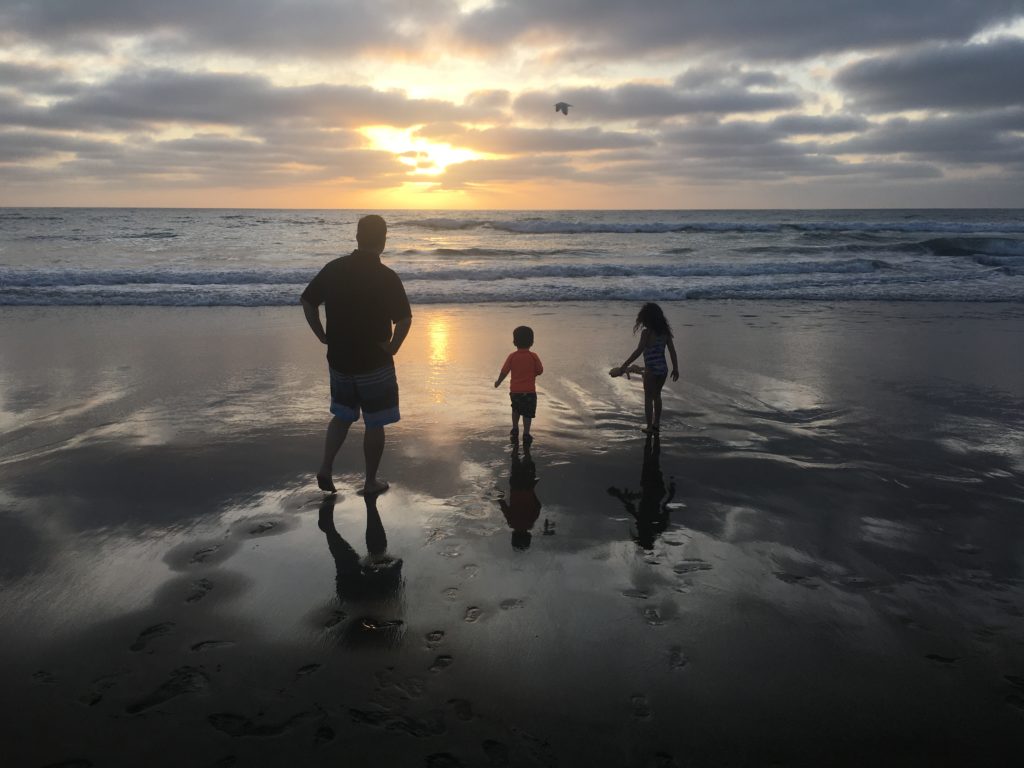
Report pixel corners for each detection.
[0,208,1024,306]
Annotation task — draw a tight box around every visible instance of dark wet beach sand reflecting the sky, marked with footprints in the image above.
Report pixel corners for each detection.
[0,302,1024,768]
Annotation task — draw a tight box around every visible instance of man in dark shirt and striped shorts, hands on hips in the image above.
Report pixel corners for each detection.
[301,215,413,494]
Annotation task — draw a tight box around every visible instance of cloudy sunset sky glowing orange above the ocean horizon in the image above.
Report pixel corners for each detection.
[0,0,1024,209]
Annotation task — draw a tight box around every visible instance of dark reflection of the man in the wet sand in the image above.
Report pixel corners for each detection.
[318,494,402,644]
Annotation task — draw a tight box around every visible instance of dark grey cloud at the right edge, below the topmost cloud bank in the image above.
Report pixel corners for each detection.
[835,38,1024,113]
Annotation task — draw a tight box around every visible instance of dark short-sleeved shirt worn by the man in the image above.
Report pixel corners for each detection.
[302,250,413,374]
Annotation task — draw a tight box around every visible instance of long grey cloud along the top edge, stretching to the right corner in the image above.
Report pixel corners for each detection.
[459,0,1022,59]
